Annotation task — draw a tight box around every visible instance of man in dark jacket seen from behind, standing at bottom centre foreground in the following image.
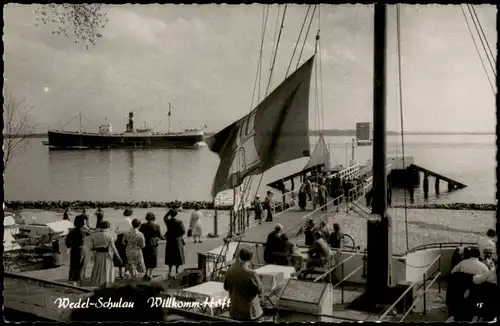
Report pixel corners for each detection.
[224,248,263,321]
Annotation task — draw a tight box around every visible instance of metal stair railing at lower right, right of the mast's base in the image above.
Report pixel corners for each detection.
[378,254,441,322]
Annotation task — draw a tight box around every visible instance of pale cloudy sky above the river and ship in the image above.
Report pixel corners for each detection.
[3,4,497,132]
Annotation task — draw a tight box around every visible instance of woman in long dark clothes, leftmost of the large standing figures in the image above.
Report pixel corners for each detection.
[65,215,90,285]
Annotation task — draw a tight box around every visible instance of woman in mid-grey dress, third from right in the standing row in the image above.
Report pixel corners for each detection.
[123,219,146,278]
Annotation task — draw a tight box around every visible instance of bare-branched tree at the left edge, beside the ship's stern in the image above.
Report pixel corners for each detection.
[2,92,34,171]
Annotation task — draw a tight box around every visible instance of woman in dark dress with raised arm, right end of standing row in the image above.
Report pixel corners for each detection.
[163,209,186,278]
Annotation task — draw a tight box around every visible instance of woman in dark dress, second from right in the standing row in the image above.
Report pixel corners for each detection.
[139,213,163,281]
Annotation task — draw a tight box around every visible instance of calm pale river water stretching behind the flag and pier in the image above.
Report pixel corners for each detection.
[5,135,496,203]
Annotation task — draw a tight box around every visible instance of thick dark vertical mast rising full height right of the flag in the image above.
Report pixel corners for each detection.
[365,3,392,307]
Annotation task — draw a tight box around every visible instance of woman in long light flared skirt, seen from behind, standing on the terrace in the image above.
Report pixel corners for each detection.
[90,221,121,286]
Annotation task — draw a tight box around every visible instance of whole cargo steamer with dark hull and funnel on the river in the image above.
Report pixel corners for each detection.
[42,105,204,149]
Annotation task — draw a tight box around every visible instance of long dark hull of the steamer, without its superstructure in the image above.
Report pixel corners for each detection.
[44,131,204,149]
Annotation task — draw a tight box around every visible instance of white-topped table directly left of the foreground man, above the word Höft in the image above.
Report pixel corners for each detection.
[178,281,229,316]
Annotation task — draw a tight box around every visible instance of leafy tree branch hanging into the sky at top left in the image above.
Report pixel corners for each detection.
[35,3,108,49]
